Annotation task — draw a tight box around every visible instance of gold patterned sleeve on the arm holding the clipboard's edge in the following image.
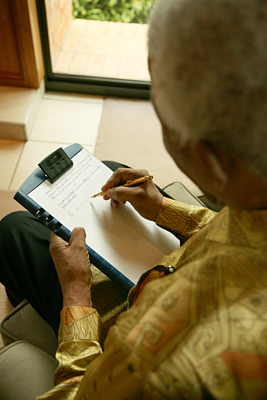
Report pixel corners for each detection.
[37,306,102,400]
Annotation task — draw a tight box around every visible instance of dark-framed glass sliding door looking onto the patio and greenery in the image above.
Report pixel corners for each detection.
[37,0,155,98]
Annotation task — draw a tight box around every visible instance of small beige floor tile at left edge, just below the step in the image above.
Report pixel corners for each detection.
[0,140,24,190]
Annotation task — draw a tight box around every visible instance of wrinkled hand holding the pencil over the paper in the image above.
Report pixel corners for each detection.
[101,168,163,221]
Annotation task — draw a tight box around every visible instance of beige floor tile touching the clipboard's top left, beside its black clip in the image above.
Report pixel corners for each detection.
[10,141,72,190]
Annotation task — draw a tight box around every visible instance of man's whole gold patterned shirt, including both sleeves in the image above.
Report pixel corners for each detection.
[39,199,267,400]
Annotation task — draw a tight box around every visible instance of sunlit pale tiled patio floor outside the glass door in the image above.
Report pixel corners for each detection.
[53,19,150,81]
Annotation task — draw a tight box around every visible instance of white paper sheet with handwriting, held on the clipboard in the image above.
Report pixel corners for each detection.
[29,149,179,283]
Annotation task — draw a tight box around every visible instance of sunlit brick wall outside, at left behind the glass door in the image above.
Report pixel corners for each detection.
[45,0,72,63]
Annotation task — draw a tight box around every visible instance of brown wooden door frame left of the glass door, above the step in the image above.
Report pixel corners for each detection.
[0,0,44,88]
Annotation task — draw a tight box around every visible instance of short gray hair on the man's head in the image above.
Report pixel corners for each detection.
[148,0,267,176]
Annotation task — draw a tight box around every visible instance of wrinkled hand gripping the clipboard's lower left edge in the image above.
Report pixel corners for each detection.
[49,228,92,307]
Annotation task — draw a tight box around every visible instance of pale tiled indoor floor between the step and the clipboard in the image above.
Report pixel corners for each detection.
[0,94,103,191]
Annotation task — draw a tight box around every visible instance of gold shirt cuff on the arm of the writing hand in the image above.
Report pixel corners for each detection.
[156,197,217,241]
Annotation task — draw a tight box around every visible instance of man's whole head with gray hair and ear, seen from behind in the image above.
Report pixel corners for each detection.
[149,0,267,208]
